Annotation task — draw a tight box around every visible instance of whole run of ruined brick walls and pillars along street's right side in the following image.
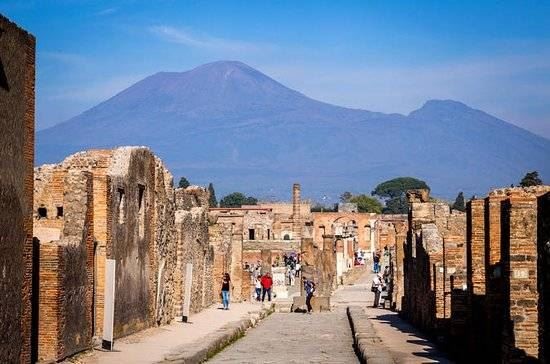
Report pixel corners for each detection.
[404,186,550,362]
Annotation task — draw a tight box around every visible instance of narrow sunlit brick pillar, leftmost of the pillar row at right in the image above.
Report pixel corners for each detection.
[466,200,485,295]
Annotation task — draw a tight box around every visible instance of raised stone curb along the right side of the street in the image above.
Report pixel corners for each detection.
[346,306,395,364]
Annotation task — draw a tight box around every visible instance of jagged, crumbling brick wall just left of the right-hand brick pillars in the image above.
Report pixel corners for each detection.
[404,191,466,331]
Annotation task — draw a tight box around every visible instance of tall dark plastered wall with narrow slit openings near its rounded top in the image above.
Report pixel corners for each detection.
[106,148,157,337]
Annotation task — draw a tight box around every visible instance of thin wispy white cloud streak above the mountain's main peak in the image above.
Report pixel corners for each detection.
[149,25,273,52]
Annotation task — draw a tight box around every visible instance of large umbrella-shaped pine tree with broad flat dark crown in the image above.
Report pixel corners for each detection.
[371,177,430,214]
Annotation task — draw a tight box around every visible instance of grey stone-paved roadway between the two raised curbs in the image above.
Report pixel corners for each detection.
[209,308,358,363]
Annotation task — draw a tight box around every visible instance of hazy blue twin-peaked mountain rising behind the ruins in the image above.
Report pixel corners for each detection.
[37,61,550,198]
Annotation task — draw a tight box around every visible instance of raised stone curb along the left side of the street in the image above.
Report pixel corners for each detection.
[159,305,274,364]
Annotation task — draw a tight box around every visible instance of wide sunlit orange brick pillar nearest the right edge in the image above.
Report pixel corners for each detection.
[501,193,539,362]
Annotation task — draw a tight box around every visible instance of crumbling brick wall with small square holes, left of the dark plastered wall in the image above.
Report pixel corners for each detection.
[35,170,94,361]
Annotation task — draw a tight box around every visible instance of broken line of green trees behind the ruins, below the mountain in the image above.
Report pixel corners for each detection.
[178,171,543,210]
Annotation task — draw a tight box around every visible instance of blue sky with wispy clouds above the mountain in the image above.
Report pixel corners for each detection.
[0,0,550,138]
